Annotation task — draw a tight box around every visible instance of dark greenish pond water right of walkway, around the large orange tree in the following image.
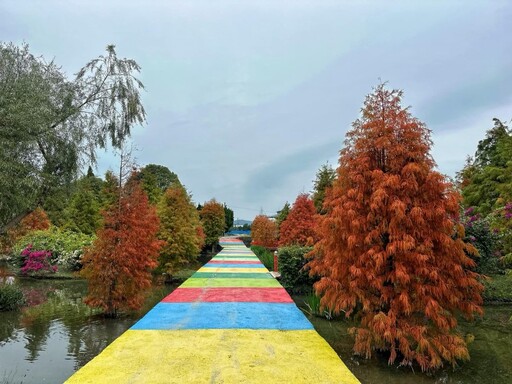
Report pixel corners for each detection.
[293,296,512,384]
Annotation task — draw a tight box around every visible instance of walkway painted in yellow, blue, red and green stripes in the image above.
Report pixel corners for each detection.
[66,238,359,384]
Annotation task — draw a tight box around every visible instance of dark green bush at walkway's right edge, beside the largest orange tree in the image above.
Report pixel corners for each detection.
[277,245,316,293]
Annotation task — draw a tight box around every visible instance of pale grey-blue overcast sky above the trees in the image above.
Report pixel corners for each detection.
[0,0,512,219]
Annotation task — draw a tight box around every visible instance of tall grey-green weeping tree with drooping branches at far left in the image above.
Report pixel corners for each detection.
[0,43,146,233]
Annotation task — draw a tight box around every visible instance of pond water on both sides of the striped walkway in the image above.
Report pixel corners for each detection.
[0,266,512,384]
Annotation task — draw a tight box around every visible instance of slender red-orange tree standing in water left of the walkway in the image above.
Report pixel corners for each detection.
[81,181,163,317]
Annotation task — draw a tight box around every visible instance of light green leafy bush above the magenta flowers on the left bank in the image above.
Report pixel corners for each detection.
[13,227,94,271]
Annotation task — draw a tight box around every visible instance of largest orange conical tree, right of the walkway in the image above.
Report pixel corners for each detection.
[309,84,483,370]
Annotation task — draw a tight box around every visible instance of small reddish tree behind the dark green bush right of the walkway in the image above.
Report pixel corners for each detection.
[279,193,318,246]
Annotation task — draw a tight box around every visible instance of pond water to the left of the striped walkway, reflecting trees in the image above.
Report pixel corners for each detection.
[0,279,175,384]
